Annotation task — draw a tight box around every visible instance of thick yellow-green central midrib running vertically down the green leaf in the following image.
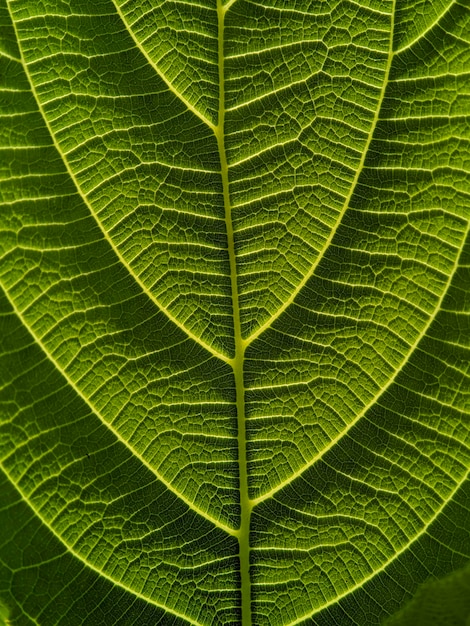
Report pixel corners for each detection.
[214,0,252,626]
